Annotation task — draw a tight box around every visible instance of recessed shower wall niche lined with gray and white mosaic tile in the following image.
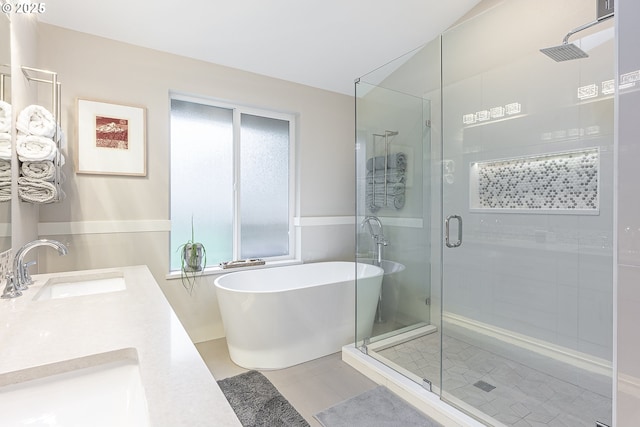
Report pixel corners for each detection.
[469,148,600,214]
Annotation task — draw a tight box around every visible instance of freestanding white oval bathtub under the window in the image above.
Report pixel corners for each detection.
[214,262,384,369]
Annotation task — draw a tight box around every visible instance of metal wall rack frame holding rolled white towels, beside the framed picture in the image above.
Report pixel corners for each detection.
[21,66,64,203]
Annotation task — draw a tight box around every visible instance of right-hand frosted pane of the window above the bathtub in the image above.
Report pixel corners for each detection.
[240,114,289,258]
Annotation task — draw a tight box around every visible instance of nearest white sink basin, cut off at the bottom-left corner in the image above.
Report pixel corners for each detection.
[0,348,149,427]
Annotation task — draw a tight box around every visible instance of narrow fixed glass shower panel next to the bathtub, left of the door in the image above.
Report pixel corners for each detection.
[355,40,440,392]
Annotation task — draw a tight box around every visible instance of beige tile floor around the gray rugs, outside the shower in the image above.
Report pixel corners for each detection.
[196,338,376,427]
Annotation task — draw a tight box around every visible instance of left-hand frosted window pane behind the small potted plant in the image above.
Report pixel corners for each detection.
[171,99,233,270]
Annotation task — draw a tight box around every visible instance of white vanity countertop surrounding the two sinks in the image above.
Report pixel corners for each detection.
[0,266,240,427]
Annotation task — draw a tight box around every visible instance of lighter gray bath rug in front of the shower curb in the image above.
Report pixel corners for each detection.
[314,386,442,427]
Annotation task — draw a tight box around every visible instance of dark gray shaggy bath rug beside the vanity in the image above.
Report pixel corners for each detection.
[218,371,309,427]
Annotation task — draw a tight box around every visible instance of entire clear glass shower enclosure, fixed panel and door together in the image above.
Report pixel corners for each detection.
[355,0,615,427]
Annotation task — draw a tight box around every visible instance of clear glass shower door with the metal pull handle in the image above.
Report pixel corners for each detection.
[441,0,614,426]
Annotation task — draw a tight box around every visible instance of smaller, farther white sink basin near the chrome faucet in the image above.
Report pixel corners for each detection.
[34,272,127,301]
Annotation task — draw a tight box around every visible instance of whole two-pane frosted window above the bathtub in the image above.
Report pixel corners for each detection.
[170,97,294,271]
